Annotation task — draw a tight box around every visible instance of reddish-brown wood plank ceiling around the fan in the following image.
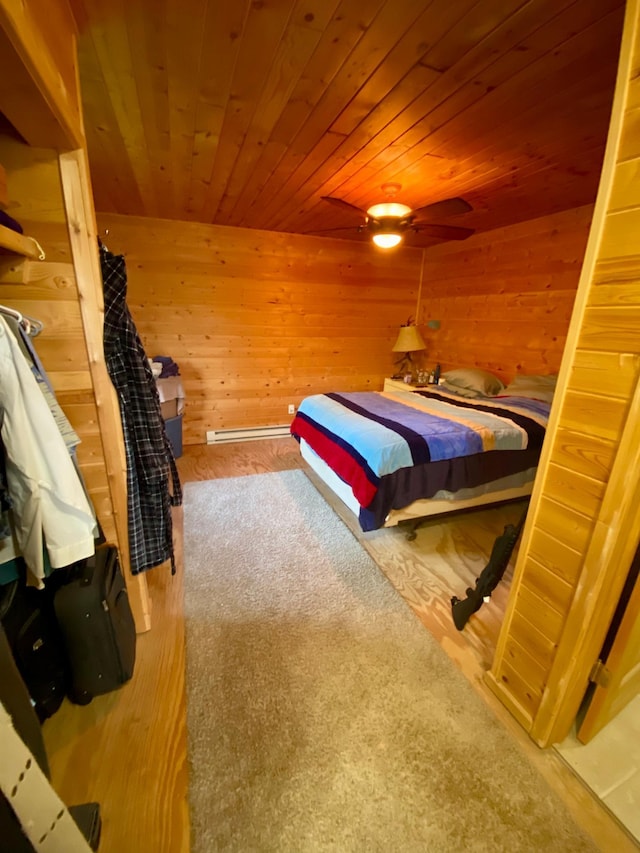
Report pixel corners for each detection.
[70,0,624,245]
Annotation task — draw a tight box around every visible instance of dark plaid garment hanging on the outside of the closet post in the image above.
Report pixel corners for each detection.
[100,245,182,574]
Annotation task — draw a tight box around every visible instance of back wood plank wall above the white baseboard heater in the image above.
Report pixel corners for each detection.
[98,214,421,444]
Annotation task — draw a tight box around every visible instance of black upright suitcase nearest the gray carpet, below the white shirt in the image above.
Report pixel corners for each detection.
[54,545,136,705]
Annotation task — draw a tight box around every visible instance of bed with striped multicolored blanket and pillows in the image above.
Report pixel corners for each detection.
[291,377,555,532]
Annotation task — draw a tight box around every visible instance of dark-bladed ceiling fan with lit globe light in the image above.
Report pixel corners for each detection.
[312,184,474,249]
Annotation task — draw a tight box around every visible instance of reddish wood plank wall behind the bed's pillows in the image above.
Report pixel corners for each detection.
[419,205,593,381]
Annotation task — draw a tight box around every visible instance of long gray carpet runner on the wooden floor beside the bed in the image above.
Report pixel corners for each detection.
[184,471,596,853]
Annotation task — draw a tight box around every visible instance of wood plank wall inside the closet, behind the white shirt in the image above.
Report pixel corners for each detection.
[0,136,118,542]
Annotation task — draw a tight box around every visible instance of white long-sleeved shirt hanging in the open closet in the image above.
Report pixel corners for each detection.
[0,315,97,585]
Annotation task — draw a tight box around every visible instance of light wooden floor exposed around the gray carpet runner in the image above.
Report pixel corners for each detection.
[44,439,637,853]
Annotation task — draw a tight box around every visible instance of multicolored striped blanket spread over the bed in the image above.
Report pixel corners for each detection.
[291,389,550,530]
